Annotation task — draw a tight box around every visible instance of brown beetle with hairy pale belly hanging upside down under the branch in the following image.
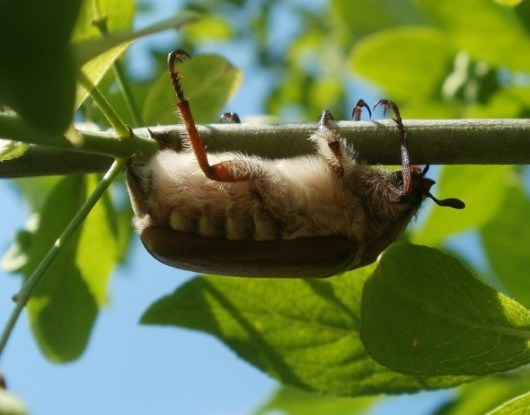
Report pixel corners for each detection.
[127,50,464,278]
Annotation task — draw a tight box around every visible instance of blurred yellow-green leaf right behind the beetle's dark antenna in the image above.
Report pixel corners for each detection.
[411,166,513,245]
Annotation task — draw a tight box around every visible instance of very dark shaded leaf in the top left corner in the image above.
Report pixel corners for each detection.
[0,0,81,133]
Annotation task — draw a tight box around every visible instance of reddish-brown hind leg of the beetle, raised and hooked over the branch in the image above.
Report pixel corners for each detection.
[167,49,263,182]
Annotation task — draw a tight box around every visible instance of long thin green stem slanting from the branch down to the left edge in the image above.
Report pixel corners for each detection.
[0,159,127,357]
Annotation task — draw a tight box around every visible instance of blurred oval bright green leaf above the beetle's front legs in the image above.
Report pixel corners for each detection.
[350,27,456,100]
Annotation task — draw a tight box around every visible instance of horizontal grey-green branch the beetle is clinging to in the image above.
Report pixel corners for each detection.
[0,117,530,177]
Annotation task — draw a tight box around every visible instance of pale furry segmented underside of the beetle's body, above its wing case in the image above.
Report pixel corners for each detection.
[143,150,372,241]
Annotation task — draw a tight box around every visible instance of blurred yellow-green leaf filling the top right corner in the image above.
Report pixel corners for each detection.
[417,0,530,72]
